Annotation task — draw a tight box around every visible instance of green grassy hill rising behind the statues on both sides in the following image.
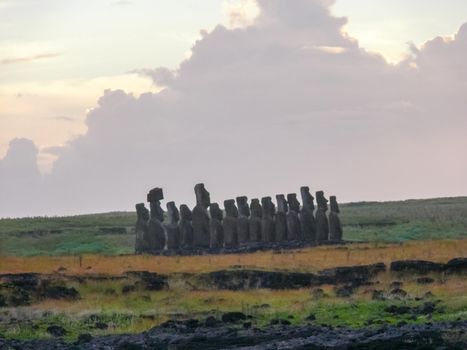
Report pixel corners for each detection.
[0,197,467,256]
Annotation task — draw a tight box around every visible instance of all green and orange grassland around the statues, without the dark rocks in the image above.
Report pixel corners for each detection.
[0,198,467,341]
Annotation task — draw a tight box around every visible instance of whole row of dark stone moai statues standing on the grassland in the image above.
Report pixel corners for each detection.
[135,184,342,253]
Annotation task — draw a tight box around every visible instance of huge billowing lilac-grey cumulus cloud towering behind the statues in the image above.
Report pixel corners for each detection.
[0,0,467,214]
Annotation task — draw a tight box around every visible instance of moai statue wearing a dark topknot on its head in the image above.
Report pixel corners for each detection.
[145,187,166,251]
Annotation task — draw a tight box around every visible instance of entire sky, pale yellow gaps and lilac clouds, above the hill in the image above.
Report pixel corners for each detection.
[0,0,467,217]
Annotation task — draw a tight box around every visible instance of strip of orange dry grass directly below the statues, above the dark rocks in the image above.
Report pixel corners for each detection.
[0,240,467,275]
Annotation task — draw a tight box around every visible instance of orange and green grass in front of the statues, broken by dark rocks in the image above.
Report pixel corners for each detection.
[0,240,467,340]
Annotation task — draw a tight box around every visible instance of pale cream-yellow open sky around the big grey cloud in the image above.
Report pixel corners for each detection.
[0,0,467,216]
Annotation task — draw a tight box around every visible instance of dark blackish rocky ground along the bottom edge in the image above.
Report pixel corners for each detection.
[0,315,467,350]
